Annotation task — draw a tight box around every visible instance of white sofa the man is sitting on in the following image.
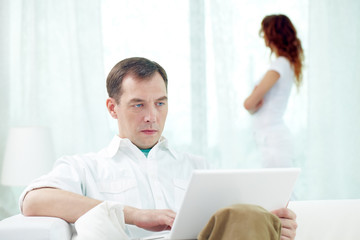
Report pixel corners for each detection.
[0,199,360,240]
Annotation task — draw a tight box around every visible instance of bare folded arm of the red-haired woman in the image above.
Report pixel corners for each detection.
[244,70,280,114]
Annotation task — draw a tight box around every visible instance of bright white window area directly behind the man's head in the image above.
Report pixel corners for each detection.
[102,0,194,150]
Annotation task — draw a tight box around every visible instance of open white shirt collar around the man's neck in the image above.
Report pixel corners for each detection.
[100,135,177,158]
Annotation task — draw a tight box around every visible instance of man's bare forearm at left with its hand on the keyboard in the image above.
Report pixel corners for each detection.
[22,188,176,231]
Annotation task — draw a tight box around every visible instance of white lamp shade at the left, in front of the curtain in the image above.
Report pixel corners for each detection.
[1,127,55,186]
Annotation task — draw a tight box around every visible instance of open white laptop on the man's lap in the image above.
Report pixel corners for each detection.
[143,168,300,240]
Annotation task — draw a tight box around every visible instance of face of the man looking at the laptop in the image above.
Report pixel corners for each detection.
[112,73,168,149]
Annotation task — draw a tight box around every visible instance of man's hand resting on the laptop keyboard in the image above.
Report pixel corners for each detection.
[124,206,176,231]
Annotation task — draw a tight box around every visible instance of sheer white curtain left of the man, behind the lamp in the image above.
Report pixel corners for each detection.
[0,0,112,218]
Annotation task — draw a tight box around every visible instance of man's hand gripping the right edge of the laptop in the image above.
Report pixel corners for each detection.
[271,208,297,240]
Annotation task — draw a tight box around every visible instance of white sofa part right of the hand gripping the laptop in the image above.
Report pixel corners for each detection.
[288,199,360,240]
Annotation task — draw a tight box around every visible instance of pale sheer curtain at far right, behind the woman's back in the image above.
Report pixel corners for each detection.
[304,0,360,199]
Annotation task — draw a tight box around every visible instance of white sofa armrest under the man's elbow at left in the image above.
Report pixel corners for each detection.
[0,214,73,240]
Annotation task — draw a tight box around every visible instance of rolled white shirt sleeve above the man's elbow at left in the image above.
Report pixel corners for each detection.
[19,157,83,212]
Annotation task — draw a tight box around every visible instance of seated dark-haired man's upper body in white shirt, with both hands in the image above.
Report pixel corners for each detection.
[20,58,296,239]
